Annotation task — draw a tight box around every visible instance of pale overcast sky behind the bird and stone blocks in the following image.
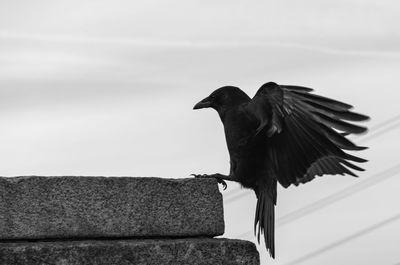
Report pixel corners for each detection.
[0,0,400,265]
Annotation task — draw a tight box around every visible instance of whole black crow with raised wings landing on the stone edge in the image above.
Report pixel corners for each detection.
[193,82,369,258]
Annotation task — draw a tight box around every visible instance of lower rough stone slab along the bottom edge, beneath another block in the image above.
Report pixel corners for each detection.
[0,238,259,265]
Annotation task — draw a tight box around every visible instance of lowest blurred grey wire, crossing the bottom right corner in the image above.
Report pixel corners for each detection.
[284,213,400,265]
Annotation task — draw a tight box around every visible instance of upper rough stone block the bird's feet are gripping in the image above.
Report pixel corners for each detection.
[0,176,224,239]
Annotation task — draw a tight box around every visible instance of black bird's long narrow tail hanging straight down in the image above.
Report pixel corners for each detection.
[254,191,275,258]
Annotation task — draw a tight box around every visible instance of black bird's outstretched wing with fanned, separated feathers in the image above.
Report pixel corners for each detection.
[252,82,369,187]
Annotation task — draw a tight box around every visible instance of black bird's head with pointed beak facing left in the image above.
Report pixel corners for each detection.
[193,86,250,112]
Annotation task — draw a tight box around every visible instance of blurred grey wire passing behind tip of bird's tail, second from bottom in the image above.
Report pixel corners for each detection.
[238,163,400,238]
